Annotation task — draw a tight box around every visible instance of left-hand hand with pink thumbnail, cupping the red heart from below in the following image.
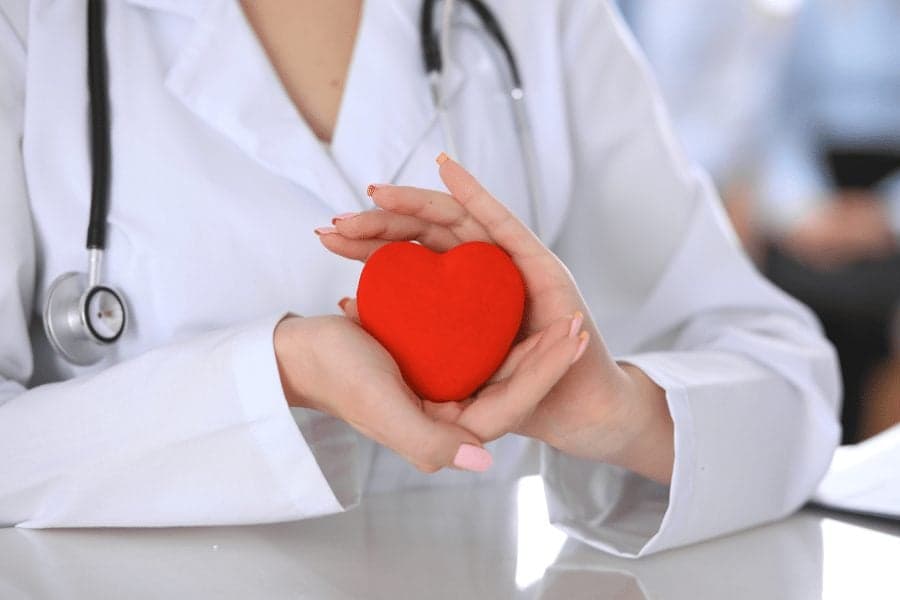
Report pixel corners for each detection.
[275,316,579,473]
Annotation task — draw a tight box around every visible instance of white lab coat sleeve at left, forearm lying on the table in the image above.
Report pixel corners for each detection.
[0,7,354,527]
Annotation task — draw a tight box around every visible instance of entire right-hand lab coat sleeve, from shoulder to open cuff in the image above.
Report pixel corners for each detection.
[541,2,840,556]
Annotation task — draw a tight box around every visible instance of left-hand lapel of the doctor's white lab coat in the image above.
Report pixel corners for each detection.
[157,0,364,212]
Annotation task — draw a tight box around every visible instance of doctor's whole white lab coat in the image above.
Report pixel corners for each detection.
[0,0,839,556]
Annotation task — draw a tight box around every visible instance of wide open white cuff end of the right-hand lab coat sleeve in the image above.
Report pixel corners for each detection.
[542,351,836,557]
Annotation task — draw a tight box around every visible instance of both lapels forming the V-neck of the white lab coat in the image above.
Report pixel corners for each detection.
[130,0,465,212]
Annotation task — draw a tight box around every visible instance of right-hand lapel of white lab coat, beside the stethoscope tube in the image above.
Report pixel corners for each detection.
[331,0,464,189]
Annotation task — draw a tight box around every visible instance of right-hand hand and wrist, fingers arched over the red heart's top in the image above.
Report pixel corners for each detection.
[317,156,674,482]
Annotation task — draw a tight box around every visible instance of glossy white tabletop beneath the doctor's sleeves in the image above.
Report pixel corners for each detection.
[0,477,900,600]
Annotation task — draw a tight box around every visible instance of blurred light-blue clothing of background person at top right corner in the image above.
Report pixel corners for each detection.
[760,0,900,234]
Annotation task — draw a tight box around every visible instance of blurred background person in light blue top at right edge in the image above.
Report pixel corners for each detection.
[758,0,900,443]
